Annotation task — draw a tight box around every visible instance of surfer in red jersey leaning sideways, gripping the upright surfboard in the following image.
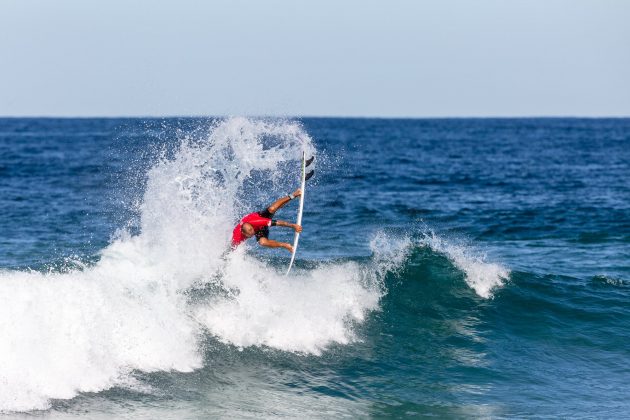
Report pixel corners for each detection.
[232,188,302,252]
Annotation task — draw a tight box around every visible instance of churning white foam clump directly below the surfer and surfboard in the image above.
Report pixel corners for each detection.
[196,249,381,354]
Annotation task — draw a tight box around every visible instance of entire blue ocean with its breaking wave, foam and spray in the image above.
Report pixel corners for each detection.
[0,118,630,419]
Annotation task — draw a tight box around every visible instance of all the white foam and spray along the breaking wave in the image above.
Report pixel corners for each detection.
[0,118,510,412]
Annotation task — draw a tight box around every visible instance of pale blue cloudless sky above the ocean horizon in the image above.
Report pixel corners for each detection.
[0,0,630,117]
